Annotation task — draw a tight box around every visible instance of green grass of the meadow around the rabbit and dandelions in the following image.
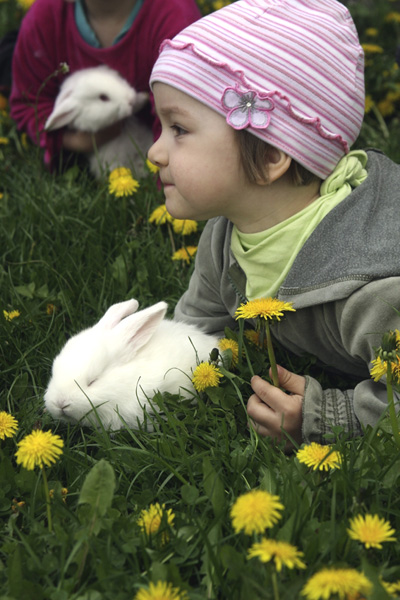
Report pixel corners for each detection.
[0,2,400,600]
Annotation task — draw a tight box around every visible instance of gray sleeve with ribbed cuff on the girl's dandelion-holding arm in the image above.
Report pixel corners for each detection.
[303,277,400,443]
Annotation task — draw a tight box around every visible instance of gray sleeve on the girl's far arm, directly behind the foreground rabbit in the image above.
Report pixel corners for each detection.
[174,217,238,334]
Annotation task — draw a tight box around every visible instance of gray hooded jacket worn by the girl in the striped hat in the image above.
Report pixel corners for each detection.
[175,150,400,443]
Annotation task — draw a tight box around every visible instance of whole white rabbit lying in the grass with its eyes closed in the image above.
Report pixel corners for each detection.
[44,299,218,431]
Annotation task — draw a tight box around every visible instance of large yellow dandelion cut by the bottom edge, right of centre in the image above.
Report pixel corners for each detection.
[301,569,372,600]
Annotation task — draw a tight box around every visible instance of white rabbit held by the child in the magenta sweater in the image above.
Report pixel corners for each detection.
[45,65,153,178]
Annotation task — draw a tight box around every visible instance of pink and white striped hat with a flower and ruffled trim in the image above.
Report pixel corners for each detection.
[150,0,364,179]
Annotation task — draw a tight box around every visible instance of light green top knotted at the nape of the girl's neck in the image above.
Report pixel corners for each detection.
[231,150,367,300]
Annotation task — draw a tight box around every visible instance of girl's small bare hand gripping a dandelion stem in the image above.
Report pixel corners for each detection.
[247,366,306,450]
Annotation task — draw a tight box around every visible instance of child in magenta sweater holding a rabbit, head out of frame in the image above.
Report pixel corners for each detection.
[10,0,200,165]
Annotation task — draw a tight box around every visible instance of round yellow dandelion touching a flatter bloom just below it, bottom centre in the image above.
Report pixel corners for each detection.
[230,490,284,535]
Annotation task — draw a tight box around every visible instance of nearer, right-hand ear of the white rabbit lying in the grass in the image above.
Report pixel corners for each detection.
[115,302,168,353]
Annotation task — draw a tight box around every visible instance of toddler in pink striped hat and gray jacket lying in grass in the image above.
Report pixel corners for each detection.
[149,0,400,443]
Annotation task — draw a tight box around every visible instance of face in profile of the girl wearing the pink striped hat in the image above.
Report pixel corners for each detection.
[149,83,251,223]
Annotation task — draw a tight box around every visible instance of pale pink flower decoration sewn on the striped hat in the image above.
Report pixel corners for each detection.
[221,87,275,129]
